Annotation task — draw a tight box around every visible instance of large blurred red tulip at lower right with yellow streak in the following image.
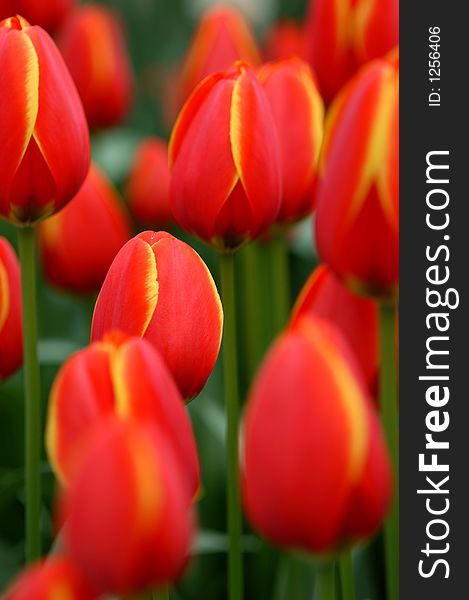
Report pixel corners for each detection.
[242,317,391,552]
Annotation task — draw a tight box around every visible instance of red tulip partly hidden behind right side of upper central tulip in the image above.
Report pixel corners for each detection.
[258,58,324,223]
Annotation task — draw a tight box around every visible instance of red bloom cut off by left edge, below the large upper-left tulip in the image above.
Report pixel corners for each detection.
[0,237,23,381]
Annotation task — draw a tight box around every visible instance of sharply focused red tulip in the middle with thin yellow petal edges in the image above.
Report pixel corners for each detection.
[91,231,223,399]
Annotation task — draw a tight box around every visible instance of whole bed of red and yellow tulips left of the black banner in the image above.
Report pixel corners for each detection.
[0,0,399,600]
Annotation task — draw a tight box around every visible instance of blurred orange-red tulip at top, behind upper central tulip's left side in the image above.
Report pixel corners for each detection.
[179,5,261,106]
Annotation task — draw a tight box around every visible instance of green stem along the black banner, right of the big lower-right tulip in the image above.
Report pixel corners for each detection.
[380,303,399,600]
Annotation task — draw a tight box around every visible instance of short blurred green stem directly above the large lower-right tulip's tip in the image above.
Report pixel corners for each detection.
[270,231,290,335]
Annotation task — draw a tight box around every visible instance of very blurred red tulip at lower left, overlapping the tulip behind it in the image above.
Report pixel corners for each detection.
[64,420,193,596]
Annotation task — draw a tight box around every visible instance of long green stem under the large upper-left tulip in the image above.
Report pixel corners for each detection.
[18,227,41,562]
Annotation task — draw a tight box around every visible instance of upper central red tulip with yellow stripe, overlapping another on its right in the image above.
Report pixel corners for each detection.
[169,63,282,249]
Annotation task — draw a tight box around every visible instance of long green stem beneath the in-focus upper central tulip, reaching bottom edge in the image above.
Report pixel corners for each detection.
[220,253,243,600]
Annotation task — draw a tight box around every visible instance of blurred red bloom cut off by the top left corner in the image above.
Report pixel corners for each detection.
[0,0,76,34]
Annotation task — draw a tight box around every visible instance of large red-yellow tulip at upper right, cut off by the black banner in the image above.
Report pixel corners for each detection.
[316,60,399,297]
